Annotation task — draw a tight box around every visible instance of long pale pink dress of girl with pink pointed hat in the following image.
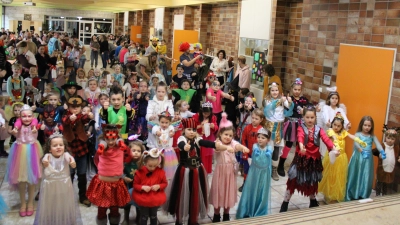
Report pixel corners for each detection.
[209,140,239,208]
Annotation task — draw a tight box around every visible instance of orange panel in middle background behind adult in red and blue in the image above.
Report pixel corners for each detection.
[172,30,198,75]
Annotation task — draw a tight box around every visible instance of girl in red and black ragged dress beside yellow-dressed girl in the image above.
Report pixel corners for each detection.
[280,105,339,212]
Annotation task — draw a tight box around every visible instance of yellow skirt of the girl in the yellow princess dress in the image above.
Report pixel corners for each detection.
[318,150,348,202]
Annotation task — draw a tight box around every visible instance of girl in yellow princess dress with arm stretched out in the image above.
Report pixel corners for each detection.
[318,113,367,203]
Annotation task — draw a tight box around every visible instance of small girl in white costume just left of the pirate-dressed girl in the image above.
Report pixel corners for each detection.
[147,108,178,180]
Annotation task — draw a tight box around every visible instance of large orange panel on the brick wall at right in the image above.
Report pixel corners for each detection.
[336,44,396,184]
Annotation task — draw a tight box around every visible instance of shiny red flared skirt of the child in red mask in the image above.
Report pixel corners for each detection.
[86,175,131,208]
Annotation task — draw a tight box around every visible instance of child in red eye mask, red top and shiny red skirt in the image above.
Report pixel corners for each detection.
[87,124,132,225]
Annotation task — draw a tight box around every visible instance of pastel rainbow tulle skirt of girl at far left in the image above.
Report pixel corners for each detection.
[5,141,43,188]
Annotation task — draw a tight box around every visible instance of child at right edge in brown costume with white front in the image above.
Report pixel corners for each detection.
[372,125,400,196]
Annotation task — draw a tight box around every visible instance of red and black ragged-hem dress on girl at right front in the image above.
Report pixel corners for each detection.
[286,123,333,196]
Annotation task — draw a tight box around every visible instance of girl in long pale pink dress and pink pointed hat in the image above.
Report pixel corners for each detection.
[210,113,250,222]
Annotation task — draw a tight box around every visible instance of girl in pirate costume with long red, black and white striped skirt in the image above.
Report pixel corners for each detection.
[165,118,233,225]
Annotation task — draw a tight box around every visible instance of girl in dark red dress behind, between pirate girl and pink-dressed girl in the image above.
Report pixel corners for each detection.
[193,102,218,174]
